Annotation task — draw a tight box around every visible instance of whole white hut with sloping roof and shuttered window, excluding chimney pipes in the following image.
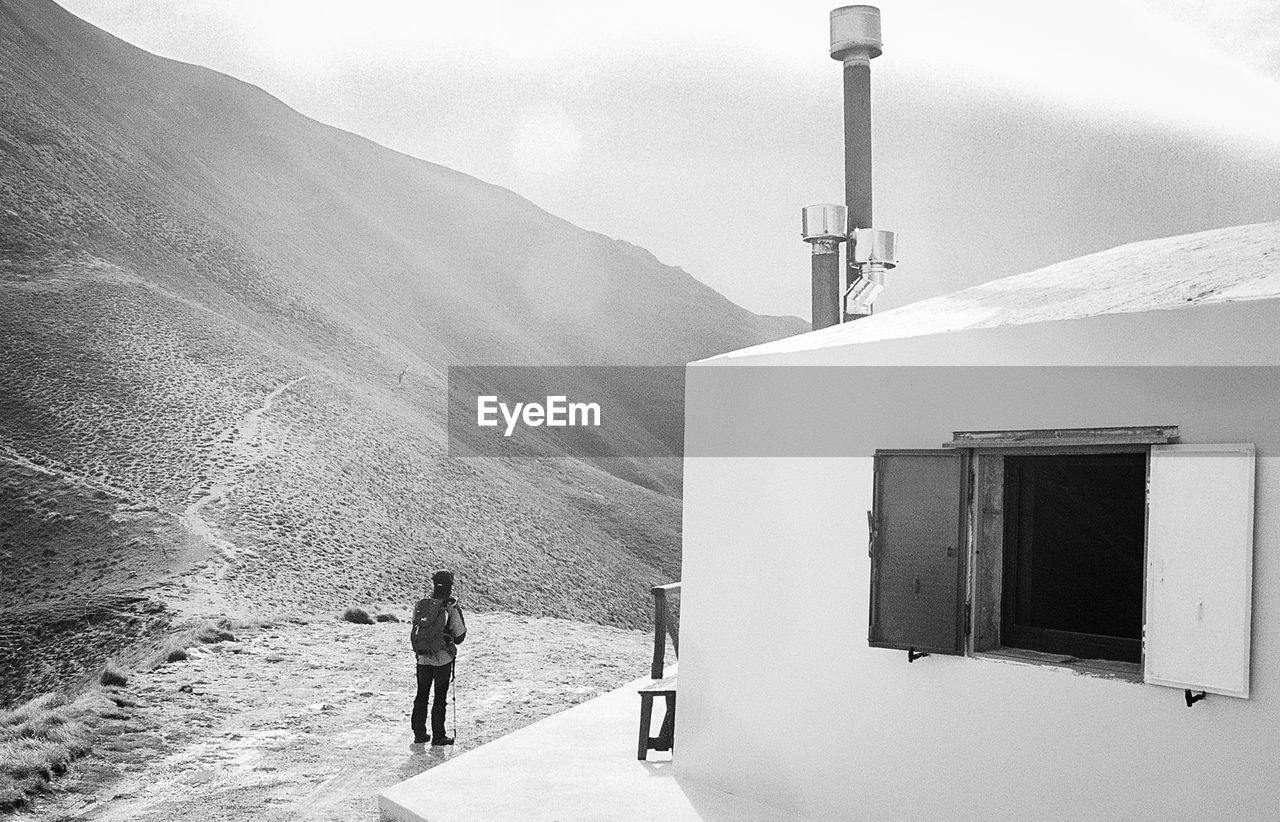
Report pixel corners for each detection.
[675,224,1280,819]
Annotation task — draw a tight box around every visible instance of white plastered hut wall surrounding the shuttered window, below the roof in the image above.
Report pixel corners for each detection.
[676,301,1280,819]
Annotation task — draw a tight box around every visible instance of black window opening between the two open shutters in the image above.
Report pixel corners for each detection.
[1001,453,1147,662]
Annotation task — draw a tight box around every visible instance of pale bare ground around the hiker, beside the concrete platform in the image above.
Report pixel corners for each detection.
[15,604,652,822]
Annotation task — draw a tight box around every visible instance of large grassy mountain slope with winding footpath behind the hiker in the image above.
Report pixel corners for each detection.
[0,0,805,702]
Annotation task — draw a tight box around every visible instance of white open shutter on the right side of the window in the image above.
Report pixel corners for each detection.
[1143,444,1254,698]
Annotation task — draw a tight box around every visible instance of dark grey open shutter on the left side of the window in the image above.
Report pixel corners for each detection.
[869,449,969,654]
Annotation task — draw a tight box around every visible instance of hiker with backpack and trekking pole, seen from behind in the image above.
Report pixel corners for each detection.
[410,570,467,746]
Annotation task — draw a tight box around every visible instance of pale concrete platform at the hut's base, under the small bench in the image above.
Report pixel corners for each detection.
[378,679,799,822]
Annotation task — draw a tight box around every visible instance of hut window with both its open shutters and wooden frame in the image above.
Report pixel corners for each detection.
[869,426,1254,697]
